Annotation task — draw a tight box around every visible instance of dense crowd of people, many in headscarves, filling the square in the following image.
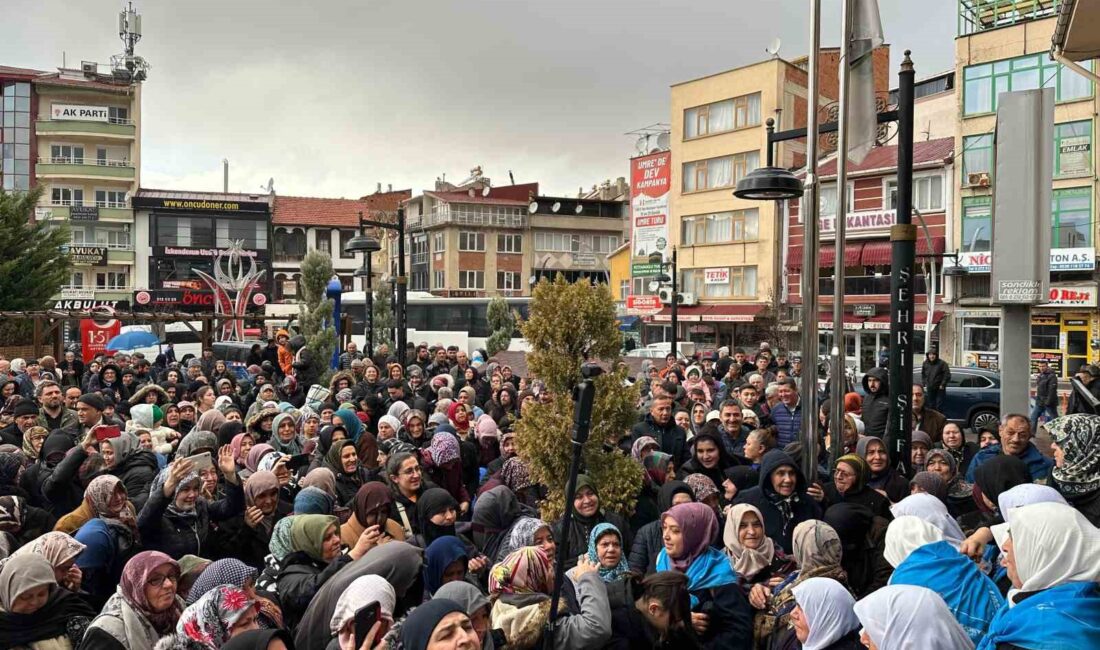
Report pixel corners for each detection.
[0,340,1100,650]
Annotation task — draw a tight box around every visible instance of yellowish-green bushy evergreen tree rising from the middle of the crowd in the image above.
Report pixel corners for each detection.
[516,274,641,520]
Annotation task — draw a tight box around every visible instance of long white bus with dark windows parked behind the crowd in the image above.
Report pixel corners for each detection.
[341,291,531,353]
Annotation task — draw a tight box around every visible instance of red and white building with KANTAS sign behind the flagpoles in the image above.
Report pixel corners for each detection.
[781,137,955,374]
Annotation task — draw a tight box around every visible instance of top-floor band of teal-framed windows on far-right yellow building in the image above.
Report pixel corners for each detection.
[963,53,1092,115]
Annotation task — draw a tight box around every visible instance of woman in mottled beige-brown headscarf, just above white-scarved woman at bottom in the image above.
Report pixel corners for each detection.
[754,519,848,647]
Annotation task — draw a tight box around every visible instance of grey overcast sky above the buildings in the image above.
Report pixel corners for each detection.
[0,0,956,197]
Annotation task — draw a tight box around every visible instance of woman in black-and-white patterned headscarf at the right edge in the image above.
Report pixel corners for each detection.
[1047,414,1100,526]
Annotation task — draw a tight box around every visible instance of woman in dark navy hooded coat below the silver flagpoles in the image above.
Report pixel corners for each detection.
[734,449,822,554]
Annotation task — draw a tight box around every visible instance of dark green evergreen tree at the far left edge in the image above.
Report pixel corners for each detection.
[0,186,72,311]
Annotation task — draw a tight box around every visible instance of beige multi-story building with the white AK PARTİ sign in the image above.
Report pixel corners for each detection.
[0,63,141,308]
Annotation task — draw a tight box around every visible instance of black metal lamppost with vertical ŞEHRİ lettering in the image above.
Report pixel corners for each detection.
[886,49,927,477]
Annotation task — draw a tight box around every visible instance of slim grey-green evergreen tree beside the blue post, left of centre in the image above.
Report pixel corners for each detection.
[298,250,338,388]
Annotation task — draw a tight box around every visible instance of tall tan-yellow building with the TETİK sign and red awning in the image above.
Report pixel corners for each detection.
[646,46,889,348]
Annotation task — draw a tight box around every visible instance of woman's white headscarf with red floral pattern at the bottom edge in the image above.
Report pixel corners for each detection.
[176,585,259,650]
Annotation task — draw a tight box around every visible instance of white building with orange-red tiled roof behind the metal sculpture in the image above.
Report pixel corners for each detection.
[272,186,413,302]
